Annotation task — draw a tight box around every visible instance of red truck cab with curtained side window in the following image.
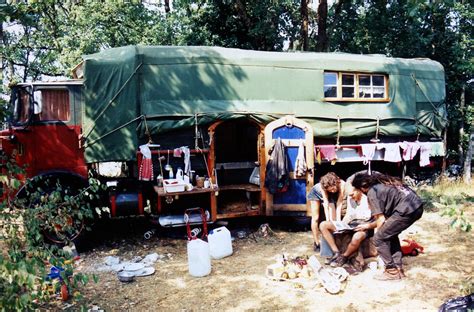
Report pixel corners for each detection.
[0,80,87,197]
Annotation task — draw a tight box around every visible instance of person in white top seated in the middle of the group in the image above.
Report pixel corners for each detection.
[319,187,374,266]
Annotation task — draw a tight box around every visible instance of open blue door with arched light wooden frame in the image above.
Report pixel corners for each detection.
[265,116,314,215]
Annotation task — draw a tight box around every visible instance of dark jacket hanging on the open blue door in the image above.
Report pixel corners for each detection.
[265,138,290,194]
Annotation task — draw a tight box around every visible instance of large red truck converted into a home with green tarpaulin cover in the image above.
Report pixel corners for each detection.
[0,45,446,240]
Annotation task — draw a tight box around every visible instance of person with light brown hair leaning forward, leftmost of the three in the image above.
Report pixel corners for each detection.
[308,172,345,251]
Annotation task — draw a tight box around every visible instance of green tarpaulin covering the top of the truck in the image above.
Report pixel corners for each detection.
[83,46,445,162]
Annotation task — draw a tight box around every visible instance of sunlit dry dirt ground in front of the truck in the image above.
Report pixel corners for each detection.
[63,209,474,311]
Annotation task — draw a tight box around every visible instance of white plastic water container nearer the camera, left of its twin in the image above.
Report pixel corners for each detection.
[188,238,211,277]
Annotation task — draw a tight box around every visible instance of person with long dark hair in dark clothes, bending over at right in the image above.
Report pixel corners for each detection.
[352,173,423,280]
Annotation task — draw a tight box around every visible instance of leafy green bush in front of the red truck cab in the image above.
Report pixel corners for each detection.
[0,156,105,311]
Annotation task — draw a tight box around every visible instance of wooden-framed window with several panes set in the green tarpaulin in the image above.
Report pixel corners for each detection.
[323,71,390,103]
